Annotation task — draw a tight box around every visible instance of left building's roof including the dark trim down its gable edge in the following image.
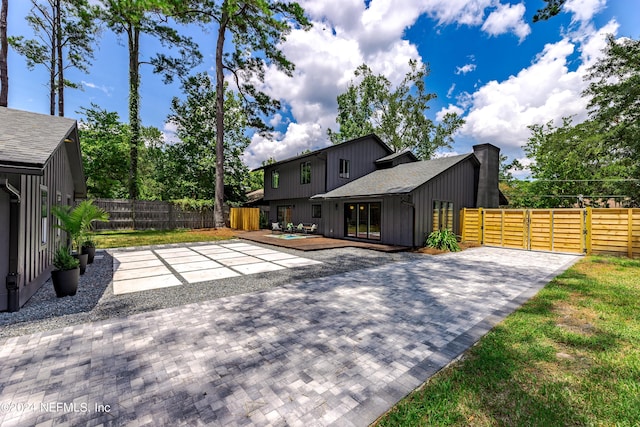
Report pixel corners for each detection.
[0,107,86,194]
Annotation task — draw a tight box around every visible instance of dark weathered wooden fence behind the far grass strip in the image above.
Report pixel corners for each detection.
[94,199,229,230]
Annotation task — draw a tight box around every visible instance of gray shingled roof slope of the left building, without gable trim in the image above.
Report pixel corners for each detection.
[0,107,76,168]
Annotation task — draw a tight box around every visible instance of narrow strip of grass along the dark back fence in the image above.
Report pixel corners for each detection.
[91,228,237,248]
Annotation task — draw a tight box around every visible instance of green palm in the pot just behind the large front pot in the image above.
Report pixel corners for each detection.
[51,200,109,274]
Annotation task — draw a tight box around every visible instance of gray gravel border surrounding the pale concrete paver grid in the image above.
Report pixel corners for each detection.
[0,239,424,338]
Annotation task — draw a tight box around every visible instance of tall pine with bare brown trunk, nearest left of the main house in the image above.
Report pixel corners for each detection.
[157,0,311,227]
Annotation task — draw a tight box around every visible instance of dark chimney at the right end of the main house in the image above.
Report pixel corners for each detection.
[473,144,500,208]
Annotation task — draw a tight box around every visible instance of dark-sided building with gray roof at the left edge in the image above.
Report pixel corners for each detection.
[0,107,87,311]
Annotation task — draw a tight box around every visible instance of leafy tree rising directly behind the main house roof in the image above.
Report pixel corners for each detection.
[327,60,464,159]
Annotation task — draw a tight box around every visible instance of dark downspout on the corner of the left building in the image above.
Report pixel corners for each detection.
[0,178,20,312]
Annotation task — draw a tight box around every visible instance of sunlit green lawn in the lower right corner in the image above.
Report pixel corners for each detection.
[376,257,640,427]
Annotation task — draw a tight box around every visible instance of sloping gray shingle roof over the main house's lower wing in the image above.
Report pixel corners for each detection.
[312,153,473,199]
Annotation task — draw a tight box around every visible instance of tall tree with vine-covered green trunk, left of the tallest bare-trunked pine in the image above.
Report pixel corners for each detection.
[100,0,202,200]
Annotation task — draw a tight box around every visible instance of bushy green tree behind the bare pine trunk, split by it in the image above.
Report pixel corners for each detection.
[167,73,251,202]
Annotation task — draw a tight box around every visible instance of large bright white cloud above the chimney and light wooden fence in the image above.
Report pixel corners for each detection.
[461,21,617,153]
